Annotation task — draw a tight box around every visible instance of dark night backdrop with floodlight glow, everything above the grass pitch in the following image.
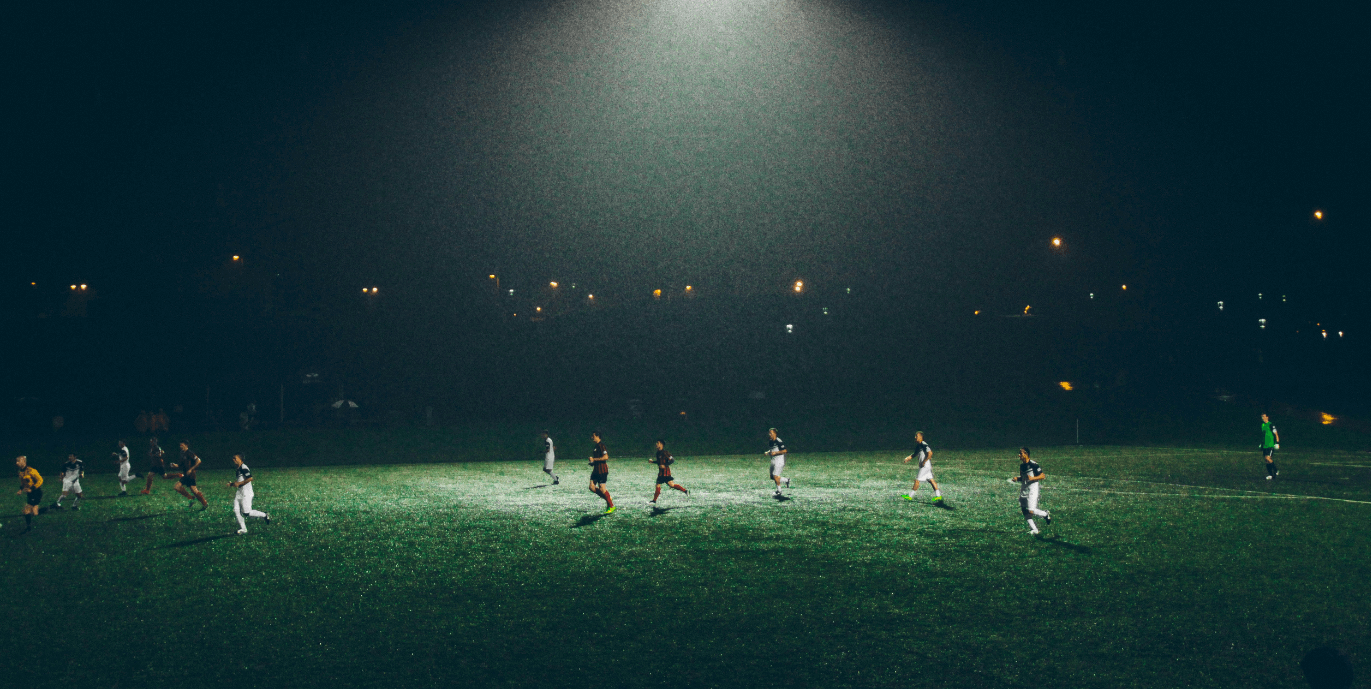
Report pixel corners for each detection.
[0,1,1371,441]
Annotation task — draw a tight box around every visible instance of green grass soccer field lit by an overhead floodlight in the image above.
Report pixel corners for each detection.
[0,447,1371,689]
